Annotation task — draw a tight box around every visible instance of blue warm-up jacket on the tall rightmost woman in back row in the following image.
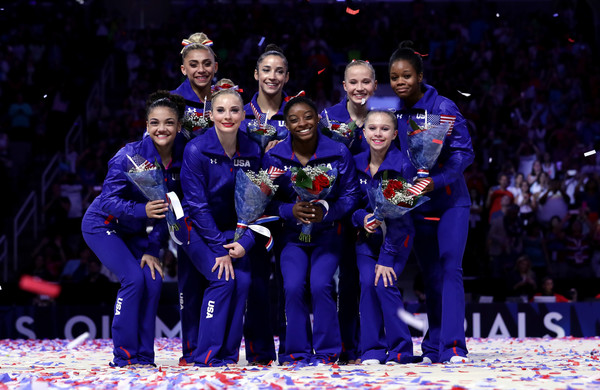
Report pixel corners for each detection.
[396,84,475,213]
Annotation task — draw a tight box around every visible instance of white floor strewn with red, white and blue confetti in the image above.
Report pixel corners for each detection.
[0,337,600,390]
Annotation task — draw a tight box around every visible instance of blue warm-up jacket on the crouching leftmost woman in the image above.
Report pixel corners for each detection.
[81,135,185,257]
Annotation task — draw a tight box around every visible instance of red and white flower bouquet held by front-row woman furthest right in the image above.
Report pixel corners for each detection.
[367,171,429,229]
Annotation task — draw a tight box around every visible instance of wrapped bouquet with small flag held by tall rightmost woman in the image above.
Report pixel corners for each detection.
[407,111,456,178]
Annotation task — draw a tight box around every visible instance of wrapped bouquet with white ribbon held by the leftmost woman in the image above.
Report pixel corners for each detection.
[125,154,183,245]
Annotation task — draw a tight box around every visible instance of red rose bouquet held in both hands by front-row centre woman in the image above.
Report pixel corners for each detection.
[291,164,337,242]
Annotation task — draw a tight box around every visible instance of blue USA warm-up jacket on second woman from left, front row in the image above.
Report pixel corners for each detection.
[181,128,261,258]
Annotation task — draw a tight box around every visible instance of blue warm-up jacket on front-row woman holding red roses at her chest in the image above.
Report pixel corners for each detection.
[263,134,359,245]
